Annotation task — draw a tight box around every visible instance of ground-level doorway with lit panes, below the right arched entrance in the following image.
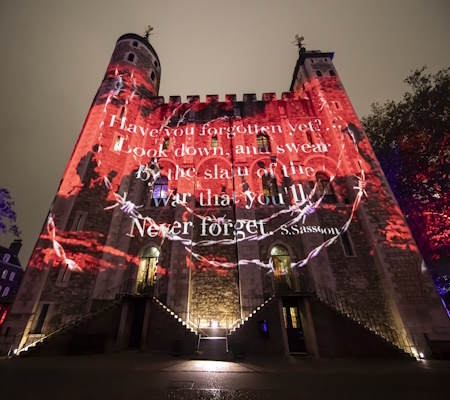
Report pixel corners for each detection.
[283,298,306,354]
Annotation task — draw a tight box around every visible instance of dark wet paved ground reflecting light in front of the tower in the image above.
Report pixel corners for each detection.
[0,352,450,400]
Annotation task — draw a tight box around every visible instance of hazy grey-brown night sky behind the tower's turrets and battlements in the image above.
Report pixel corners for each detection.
[0,0,450,265]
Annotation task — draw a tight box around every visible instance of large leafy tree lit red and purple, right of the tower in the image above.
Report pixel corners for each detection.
[362,67,450,305]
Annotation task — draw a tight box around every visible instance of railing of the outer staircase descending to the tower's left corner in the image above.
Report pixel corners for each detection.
[14,279,136,355]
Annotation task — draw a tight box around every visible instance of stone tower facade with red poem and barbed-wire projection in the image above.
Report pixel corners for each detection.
[0,34,450,356]
